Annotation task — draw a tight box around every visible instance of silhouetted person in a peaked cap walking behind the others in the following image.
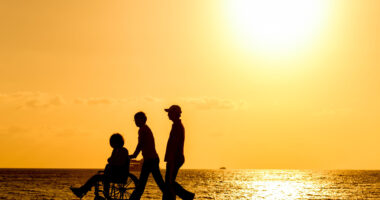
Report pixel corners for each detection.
[165,105,195,200]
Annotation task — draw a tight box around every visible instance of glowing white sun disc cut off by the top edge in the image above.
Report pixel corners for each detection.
[226,0,327,56]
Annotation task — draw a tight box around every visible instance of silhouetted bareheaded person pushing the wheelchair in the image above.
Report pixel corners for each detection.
[130,112,166,200]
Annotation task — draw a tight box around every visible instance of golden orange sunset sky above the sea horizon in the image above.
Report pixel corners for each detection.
[0,0,380,169]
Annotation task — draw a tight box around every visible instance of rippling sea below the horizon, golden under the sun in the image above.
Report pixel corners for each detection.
[0,169,380,200]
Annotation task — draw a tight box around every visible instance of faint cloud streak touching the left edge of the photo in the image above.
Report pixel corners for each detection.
[0,92,65,108]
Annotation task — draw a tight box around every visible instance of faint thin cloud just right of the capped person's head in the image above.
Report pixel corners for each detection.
[182,97,246,110]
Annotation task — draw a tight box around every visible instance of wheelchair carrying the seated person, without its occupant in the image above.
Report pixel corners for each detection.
[94,171,138,200]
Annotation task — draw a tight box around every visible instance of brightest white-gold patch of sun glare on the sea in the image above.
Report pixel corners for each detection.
[215,170,323,199]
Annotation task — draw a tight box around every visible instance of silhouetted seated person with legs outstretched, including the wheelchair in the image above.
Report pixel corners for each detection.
[70,133,138,200]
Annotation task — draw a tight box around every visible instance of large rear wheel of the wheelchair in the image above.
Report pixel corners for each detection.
[109,174,138,200]
